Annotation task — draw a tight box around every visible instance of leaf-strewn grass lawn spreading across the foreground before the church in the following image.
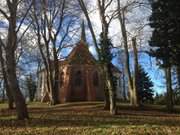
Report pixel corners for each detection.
[0,102,180,135]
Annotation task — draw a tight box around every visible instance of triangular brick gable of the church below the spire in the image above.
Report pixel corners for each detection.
[67,41,97,65]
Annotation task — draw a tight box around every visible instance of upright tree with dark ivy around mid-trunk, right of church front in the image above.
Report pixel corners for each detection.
[97,0,116,114]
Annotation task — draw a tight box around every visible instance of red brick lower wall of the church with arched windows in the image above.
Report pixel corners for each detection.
[59,65,104,103]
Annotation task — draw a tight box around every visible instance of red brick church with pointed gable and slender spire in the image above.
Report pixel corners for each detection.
[37,22,120,103]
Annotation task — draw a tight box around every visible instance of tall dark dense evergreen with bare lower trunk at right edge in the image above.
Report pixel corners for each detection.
[150,0,180,111]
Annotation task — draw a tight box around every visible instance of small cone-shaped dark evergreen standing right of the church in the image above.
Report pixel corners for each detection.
[137,66,154,103]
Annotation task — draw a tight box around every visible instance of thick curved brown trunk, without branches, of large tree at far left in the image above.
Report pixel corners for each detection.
[5,5,28,119]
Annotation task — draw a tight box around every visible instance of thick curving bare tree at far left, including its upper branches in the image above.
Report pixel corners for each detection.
[0,0,32,119]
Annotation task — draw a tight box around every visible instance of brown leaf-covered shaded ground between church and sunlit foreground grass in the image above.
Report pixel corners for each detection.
[0,103,180,128]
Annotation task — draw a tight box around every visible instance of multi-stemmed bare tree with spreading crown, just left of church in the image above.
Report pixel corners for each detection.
[31,0,80,104]
